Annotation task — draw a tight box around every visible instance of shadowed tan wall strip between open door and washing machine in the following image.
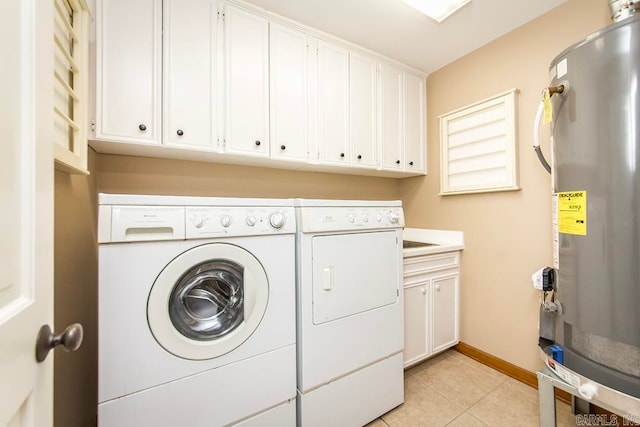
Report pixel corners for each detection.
[54,150,98,427]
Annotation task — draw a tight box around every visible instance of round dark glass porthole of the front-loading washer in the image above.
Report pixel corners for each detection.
[168,259,245,341]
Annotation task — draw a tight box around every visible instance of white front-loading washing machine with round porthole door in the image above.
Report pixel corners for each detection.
[98,194,296,427]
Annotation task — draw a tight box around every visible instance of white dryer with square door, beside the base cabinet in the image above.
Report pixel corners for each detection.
[294,199,404,427]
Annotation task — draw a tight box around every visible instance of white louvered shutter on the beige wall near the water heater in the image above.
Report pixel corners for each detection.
[439,89,519,195]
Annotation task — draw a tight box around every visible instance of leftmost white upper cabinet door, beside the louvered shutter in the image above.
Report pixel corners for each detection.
[95,0,162,144]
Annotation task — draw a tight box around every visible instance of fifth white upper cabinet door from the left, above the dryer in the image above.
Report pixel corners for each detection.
[317,41,349,166]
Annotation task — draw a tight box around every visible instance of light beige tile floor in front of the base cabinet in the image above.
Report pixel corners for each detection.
[367,350,576,427]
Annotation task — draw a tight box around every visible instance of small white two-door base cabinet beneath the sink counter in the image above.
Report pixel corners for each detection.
[404,251,460,367]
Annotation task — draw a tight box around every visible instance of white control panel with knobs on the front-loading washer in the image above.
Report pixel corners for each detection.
[185,206,296,239]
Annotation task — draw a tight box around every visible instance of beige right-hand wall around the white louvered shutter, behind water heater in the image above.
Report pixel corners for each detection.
[402,0,610,371]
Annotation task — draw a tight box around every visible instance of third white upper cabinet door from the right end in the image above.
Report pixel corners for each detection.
[349,53,378,168]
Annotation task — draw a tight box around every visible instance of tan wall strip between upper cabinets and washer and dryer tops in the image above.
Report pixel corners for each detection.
[98,155,400,200]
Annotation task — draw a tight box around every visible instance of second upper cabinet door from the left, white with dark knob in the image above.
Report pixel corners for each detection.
[163,0,218,147]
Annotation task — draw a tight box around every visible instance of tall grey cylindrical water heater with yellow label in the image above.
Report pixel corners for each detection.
[541,5,640,412]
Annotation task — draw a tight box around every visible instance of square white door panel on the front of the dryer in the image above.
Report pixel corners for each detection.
[312,231,401,325]
